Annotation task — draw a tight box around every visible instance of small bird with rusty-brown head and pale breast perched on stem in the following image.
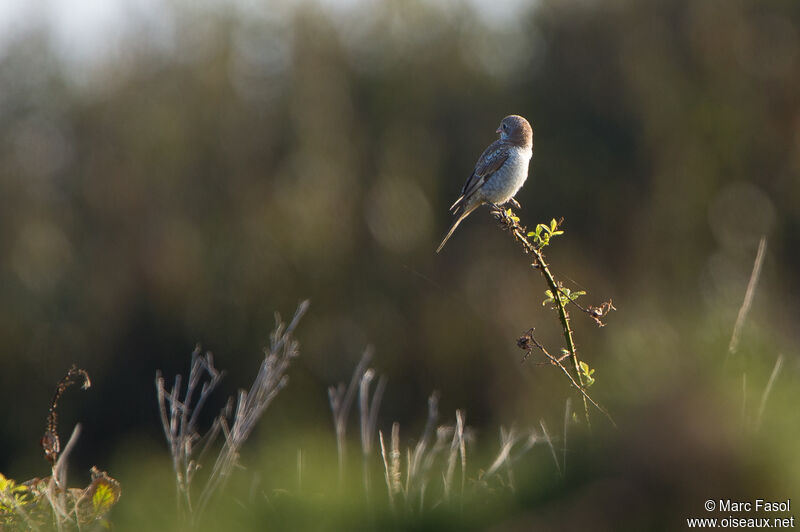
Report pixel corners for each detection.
[436,115,533,253]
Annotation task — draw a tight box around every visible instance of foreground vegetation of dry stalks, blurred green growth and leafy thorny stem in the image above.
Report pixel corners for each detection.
[0,214,800,530]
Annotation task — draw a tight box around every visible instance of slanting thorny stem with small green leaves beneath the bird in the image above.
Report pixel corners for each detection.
[492,206,613,427]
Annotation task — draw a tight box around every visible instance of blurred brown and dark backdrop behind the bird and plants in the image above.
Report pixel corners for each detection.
[0,0,800,529]
